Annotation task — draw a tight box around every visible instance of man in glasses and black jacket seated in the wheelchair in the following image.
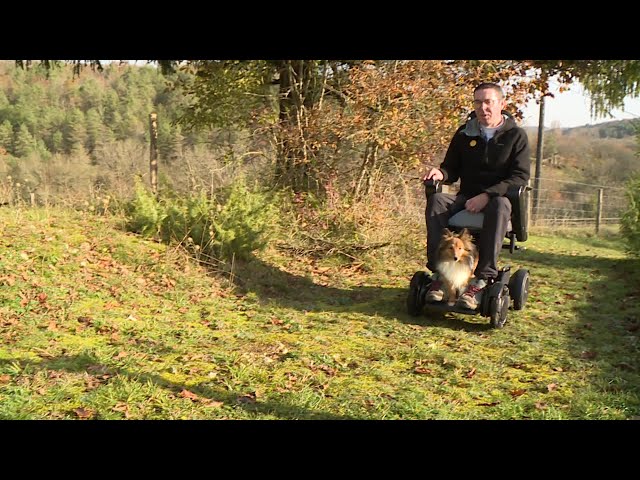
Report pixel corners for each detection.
[423,83,531,310]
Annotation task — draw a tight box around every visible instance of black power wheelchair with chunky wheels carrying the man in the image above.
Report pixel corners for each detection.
[407,179,531,328]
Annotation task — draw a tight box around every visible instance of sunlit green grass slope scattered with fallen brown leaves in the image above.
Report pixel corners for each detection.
[0,208,640,419]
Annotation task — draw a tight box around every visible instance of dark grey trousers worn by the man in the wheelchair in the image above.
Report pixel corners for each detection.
[425,192,511,280]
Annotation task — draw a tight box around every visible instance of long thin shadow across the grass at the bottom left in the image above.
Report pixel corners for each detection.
[0,354,357,420]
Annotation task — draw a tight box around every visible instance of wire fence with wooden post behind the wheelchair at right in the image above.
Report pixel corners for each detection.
[530,177,627,232]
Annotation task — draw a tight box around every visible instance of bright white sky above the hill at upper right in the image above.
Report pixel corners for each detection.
[523,84,640,128]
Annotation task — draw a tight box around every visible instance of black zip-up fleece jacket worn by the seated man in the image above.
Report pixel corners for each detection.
[440,111,531,198]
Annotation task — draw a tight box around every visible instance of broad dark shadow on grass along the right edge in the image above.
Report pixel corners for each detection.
[522,246,640,416]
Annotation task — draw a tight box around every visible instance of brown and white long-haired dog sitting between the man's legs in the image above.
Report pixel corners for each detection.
[436,228,478,305]
